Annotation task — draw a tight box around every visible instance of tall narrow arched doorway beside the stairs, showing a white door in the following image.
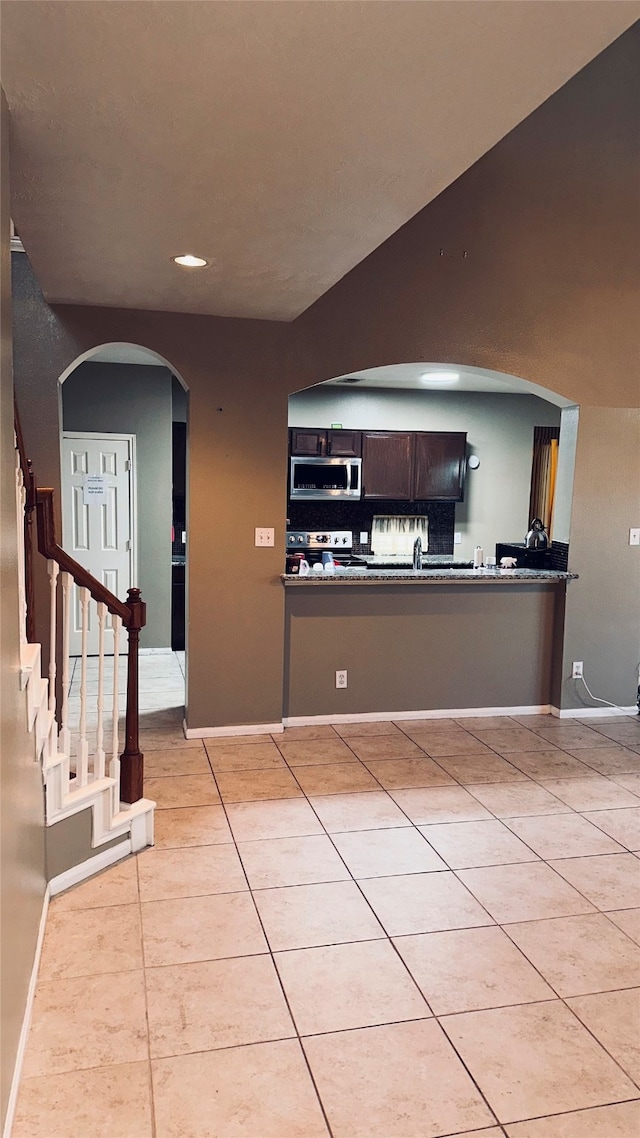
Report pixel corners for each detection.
[59,343,188,726]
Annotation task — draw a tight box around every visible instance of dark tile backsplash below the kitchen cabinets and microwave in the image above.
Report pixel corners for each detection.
[287,498,456,554]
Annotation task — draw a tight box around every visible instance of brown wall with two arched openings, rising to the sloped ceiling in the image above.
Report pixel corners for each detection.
[8,28,640,727]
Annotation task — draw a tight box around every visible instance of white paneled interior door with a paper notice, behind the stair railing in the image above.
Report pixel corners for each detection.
[61,431,136,655]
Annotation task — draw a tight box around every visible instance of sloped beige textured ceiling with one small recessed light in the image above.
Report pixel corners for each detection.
[2,0,640,320]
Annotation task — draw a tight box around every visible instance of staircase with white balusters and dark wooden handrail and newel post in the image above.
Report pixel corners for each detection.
[16,417,155,878]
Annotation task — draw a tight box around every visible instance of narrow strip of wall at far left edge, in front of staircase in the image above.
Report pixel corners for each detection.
[0,91,46,1121]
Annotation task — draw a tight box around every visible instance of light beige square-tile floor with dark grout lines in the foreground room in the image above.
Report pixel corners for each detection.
[15,659,640,1138]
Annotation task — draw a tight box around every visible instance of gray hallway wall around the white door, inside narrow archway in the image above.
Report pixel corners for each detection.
[63,361,172,648]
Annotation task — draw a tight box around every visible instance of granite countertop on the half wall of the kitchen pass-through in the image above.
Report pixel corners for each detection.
[280,567,577,586]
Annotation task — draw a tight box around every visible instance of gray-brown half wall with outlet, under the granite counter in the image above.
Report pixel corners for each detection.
[285,583,558,716]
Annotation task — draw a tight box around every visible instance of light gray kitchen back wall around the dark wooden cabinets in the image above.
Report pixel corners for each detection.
[289,386,560,560]
